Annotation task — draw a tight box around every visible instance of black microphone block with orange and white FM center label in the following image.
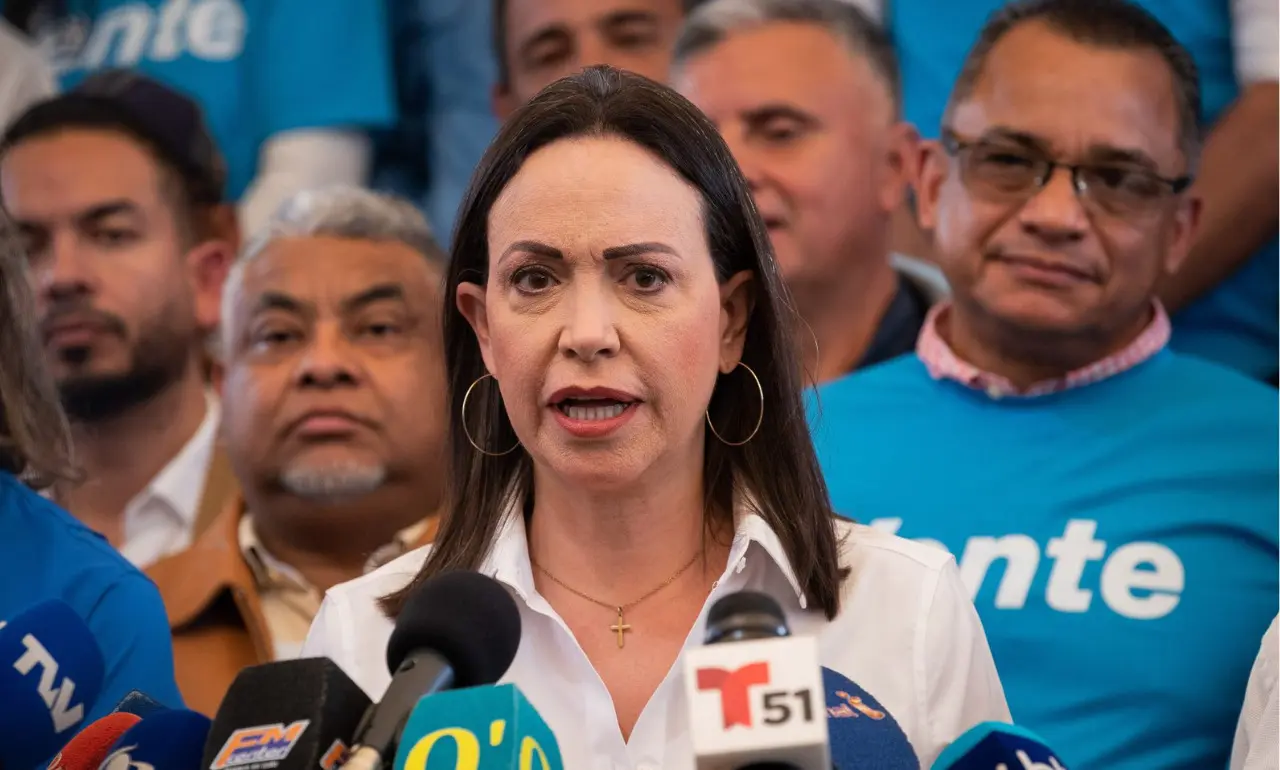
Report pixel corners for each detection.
[199,657,370,770]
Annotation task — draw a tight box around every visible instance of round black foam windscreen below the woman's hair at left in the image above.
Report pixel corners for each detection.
[387,572,520,688]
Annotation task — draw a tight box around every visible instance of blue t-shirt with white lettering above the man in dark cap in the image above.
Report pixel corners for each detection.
[26,0,396,201]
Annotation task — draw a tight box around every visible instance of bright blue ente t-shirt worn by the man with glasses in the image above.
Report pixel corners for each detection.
[810,350,1280,770]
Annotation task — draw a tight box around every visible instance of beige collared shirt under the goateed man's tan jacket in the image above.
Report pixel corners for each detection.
[237,512,431,660]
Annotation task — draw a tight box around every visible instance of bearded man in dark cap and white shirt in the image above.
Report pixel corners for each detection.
[0,72,233,567]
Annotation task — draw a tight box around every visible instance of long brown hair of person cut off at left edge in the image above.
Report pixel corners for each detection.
[0,211,78,489]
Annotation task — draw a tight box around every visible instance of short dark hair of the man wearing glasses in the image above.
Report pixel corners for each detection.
[942,0,1202,169]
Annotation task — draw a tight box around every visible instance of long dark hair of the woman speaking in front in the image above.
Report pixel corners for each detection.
[383,67,844,618]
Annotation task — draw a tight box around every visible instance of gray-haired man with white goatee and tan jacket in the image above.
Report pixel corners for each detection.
[148,188,447,714]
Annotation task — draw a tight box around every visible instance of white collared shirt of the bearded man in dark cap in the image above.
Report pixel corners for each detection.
[120,395,220,569]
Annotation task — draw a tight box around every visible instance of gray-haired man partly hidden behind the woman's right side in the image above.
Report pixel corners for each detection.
[672,0,945,382]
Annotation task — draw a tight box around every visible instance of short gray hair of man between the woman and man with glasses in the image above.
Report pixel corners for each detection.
[670,0,901,114]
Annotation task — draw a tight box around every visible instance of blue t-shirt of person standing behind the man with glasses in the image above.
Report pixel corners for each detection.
[887,0,1280,379]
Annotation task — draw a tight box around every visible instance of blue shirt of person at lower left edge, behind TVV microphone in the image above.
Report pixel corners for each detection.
[0,472,182,724]
